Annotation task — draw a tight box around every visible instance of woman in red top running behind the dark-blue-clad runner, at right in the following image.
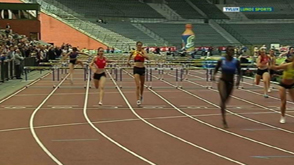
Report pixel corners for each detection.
[255,49,271,98]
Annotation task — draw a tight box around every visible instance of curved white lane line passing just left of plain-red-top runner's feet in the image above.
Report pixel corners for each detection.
[83,71,155,165]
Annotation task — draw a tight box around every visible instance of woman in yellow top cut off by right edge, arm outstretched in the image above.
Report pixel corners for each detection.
[270,58,294,124]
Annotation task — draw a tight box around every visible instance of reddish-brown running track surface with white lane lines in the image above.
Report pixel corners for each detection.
[0,71,294,165]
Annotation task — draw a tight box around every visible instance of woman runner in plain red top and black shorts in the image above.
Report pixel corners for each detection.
[90,47,111,105]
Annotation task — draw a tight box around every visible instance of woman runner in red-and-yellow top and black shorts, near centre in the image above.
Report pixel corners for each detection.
[128,41,149,105]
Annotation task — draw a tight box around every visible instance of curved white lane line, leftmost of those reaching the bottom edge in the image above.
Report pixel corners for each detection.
[30,74,69,165]
